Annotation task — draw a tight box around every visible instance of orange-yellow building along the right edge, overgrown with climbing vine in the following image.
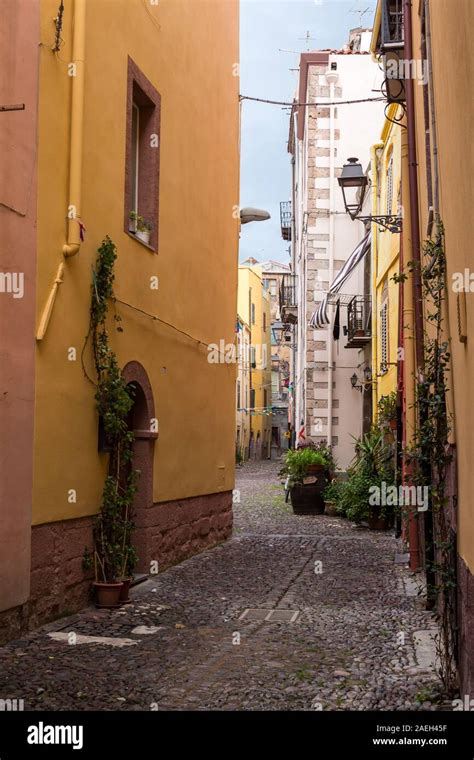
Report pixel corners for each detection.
[373,0,474,695]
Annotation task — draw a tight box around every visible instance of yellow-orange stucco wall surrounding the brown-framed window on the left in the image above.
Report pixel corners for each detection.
[33,0,239,524]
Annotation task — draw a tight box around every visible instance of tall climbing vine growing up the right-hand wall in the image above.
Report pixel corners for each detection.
[408,221,457,694]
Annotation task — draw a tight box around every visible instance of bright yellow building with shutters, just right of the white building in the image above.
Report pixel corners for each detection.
[371,104,402,419]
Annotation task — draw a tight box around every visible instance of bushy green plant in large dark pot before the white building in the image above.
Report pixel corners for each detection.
[280,447,328,514]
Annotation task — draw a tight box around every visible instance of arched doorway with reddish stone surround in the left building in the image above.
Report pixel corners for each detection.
[122,361,158,574]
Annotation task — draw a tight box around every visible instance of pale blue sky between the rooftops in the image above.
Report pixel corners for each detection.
[239,0,375,263]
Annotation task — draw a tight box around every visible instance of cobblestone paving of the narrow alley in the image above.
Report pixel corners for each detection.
[0,462,446,710]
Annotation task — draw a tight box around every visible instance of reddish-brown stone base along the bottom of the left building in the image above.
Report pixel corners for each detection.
[0,491,232,644]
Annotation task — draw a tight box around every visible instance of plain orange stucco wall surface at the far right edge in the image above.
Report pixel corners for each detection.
[412,0,474,572]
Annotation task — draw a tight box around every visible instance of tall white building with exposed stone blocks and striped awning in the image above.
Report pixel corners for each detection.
[282,29,384,469]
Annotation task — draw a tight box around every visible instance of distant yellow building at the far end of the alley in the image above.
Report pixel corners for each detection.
[238,265,272,459]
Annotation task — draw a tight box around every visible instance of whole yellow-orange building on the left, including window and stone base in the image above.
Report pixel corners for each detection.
[0,0,239,625]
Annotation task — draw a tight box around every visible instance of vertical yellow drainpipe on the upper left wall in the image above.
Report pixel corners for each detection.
[63,0,86,258]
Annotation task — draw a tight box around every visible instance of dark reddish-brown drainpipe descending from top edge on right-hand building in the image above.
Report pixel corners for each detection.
[403,0,435,580]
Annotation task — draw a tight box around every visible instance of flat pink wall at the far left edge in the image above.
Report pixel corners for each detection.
[0,0,40,610]
